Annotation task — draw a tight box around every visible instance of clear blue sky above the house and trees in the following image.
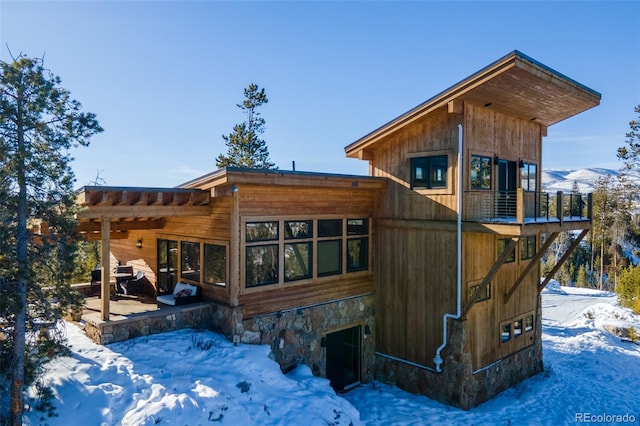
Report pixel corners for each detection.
[0,0,640,187]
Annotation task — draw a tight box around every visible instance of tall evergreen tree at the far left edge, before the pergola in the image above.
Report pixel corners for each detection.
[0,55,102,425]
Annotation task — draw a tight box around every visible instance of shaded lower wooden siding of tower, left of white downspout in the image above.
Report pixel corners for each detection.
[376,222,456,368]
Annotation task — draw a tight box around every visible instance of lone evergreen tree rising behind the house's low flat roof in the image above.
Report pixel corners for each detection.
[216,83,277,169]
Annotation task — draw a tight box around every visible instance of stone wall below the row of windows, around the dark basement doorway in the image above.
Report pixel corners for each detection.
[236,295,375,383]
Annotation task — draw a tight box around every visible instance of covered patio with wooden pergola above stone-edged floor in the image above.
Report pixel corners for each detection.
[77,186,213,344]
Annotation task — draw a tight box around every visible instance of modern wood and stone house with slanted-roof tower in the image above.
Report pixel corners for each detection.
[79,51,600,409]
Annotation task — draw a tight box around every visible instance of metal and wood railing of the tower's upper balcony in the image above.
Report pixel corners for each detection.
[465,189,592,224]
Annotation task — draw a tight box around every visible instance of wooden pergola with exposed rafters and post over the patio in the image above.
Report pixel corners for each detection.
[77,186,211,321]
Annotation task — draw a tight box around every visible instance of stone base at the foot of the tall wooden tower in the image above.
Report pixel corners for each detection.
[375,296,543,410]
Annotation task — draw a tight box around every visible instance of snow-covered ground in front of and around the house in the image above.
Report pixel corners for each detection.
[25,282,640,426]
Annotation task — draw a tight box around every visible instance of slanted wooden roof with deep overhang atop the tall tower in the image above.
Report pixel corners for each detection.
[345,50,601,158]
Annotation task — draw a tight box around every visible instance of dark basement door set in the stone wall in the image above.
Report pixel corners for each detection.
[326,326,362,392]
